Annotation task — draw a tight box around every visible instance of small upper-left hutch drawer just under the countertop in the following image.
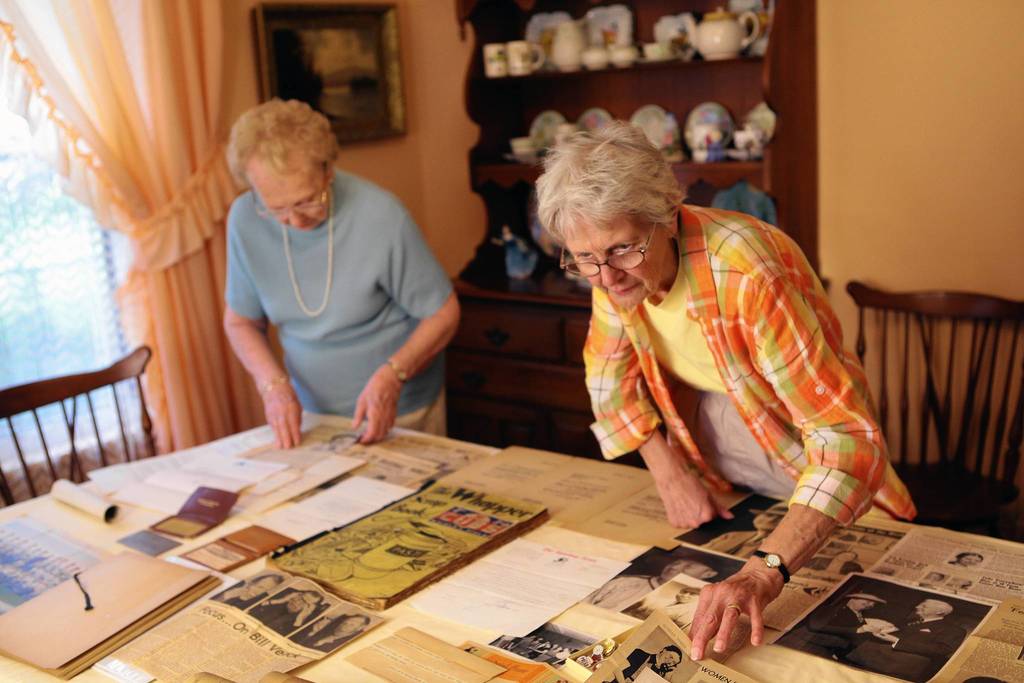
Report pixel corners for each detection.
[452,302,562,360]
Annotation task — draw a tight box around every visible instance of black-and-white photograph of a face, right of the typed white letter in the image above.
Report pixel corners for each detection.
[585,546,743,611]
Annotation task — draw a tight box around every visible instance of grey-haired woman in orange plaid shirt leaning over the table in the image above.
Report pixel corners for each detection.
[537,123,914,659]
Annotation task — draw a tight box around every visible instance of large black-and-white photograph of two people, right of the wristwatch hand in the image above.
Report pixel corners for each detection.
[776,574,991,683]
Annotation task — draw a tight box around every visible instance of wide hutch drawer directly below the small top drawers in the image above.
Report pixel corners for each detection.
[446,350,590,411]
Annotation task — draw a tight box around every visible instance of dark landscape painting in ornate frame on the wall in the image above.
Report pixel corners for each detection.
[253,4,406,143]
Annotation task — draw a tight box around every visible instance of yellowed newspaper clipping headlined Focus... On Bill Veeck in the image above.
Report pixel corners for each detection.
[97,571,381,681]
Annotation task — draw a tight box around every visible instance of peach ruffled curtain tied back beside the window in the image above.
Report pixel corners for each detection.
[0,0,261,451]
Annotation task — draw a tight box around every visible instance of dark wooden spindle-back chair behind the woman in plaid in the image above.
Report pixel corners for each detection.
[846,281,1024,533]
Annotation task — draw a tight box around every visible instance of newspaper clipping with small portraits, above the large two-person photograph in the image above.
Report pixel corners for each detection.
[870,529,1024,601]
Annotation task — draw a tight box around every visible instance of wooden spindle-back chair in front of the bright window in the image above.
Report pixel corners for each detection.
[0,346,155,505]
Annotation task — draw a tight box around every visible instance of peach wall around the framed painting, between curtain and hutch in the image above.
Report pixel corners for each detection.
[224,0,484,275]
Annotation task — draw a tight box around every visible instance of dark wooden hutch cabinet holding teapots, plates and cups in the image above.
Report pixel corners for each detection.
[446,0,818,457]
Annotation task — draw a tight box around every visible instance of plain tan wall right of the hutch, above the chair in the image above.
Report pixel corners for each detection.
[818,0,1024,335]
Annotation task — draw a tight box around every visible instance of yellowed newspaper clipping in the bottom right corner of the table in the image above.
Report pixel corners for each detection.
[934,600,1024,683]
